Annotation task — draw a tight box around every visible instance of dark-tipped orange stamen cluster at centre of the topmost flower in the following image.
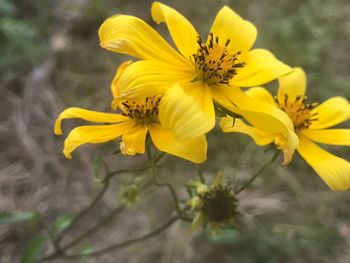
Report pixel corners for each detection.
[192,33,245,84]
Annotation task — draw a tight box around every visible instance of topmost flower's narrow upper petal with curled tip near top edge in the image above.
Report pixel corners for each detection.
[152,2,198,59]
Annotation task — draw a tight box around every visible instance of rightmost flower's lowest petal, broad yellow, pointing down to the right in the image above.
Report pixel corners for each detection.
[298,136,350,191]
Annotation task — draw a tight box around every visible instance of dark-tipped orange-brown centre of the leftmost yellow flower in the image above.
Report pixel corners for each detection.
[120,96,161,125]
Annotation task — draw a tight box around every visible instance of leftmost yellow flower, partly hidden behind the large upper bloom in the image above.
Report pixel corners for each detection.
[54,86,207,163]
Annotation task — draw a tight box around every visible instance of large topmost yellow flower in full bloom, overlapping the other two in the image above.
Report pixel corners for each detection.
[99,2,298,148]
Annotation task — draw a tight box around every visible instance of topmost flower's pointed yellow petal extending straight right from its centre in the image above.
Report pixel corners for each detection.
[231,49,292,87]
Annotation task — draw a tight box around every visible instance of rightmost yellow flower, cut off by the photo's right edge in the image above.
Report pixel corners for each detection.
[220,68,350,191]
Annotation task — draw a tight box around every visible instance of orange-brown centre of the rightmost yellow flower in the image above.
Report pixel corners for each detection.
[275,94,317,131]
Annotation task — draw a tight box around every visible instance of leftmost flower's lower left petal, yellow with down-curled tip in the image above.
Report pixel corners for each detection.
[63,121,133,159]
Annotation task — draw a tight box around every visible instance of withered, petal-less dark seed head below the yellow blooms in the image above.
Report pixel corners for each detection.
[188,173,238,232]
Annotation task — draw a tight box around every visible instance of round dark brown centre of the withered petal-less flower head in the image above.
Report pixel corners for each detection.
[201,185,237,223]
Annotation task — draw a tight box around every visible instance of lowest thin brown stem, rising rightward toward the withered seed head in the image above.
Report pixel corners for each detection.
[56,217,180,259]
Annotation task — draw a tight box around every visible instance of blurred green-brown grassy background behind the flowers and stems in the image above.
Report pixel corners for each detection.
[0,0,350,263]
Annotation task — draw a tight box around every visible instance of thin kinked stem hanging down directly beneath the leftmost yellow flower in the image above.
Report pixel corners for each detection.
[146,140,182,215]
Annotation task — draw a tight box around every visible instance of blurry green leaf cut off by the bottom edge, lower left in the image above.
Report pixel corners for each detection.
[21,235,48,263]
